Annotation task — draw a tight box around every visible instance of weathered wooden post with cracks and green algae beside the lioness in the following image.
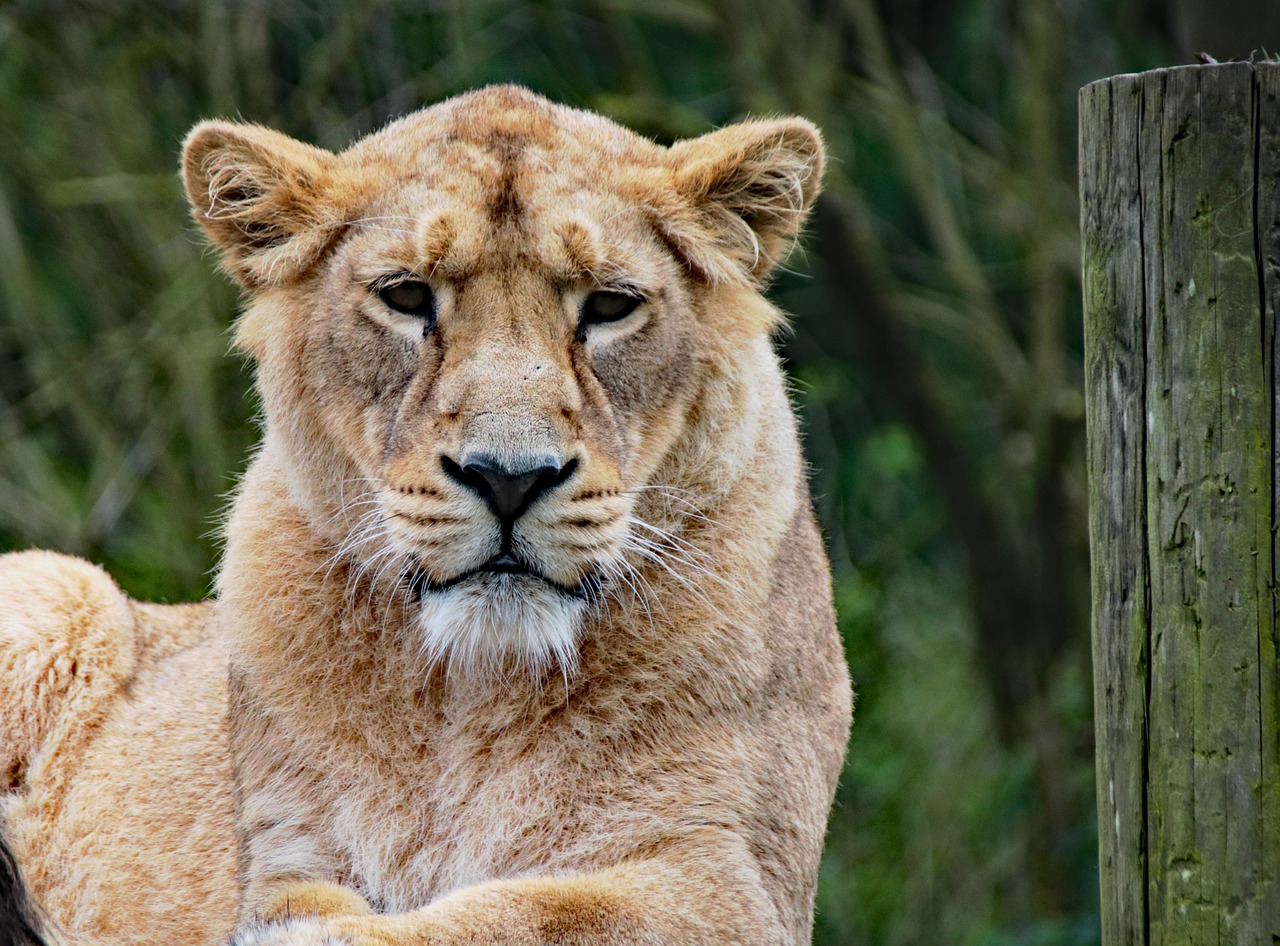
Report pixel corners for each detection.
[1080,63,1280,946]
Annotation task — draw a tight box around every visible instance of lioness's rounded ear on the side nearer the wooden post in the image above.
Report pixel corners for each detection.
[668,118,826,282]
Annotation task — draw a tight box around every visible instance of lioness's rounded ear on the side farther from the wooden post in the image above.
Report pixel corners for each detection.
[182,122,342,289]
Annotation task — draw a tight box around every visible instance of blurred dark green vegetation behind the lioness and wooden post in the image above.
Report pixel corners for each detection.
[0,0,1280,946]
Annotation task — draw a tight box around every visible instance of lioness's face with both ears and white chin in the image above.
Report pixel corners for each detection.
[184,87,822,669]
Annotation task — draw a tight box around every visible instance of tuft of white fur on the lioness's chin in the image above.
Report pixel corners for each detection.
[417,575,586,677]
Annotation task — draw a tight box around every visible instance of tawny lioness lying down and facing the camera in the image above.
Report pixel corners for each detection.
[0,87,850,946]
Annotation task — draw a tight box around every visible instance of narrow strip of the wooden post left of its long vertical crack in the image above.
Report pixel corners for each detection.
[1080,68,1151,943]
